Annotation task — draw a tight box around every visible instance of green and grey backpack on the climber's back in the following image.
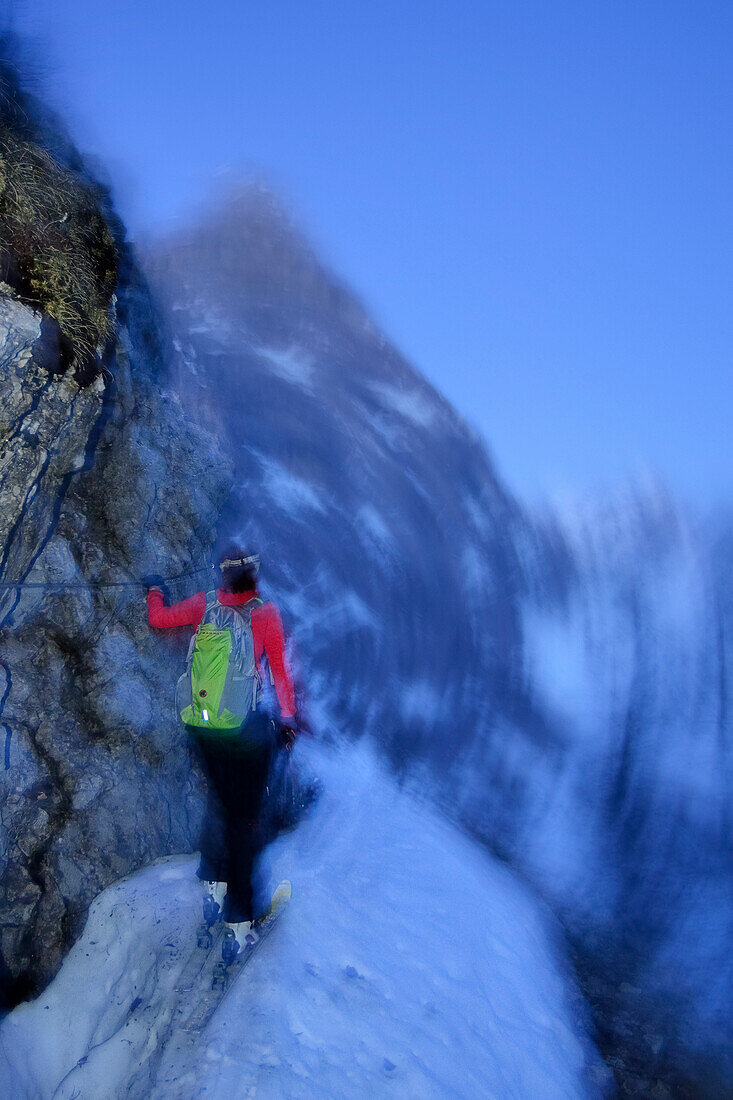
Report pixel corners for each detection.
[176,592,262,734]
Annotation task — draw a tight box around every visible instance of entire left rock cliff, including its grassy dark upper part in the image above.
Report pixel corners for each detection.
[0,55,229,1005]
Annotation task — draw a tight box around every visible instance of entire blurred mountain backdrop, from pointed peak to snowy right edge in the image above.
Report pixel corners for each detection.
[147,187,733,1095]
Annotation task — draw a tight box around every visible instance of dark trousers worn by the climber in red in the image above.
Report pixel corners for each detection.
[189,712,273,922]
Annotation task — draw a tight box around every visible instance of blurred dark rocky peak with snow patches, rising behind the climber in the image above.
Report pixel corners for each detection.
[146,187,528,769]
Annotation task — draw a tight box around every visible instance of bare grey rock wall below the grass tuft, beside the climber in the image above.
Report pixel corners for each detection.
[0,257,229,1003]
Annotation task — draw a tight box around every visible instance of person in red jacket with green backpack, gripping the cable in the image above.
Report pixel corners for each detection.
[147,546,299,963]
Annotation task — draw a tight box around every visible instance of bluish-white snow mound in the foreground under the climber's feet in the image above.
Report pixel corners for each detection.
[0,744,608,1100]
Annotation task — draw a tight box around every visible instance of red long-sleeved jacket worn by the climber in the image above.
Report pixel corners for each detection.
[147,589,295,719]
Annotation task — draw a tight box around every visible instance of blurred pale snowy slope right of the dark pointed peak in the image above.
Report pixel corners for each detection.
[497,490,733,1073]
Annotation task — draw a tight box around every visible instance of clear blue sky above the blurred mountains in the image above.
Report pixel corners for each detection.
[7,0,733,505]
